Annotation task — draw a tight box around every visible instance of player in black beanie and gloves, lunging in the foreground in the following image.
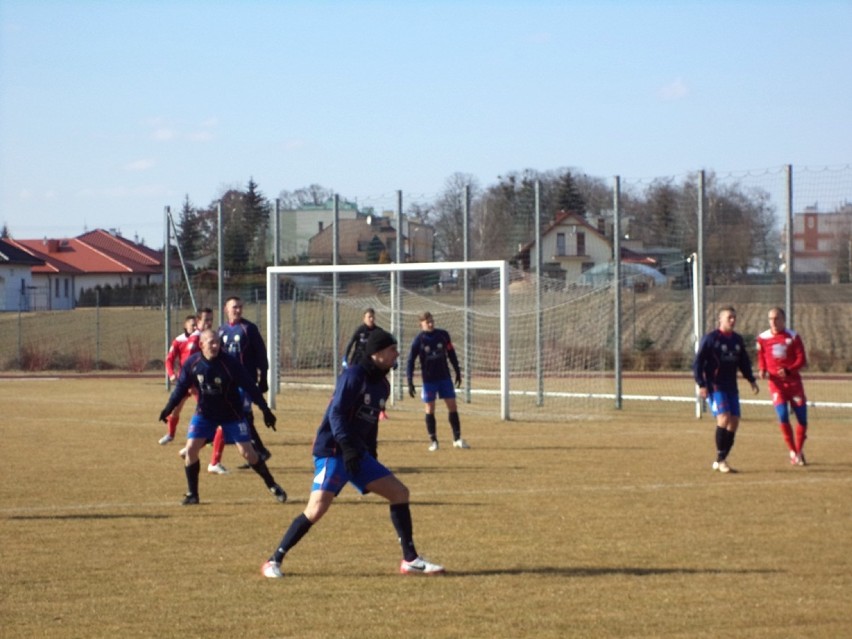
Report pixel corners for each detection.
[261,328,444,579]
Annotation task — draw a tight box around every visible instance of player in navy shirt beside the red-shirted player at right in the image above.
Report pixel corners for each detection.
[692,306,760,473]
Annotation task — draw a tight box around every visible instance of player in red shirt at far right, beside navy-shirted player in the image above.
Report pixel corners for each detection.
[757,306,808,466]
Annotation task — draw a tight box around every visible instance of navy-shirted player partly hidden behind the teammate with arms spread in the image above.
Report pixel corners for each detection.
[219,296,272,468]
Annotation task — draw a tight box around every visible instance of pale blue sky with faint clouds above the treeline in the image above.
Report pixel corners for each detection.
[0,0,852,247]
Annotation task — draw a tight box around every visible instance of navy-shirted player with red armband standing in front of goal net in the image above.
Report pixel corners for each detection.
[405,311,470,452]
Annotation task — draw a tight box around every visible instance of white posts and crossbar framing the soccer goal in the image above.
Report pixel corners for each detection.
[266,260,510,420]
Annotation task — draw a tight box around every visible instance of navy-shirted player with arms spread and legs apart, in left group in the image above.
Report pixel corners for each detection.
[160,330,287,506]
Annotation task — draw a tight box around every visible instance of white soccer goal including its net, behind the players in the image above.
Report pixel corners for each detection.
[267,261,614,420]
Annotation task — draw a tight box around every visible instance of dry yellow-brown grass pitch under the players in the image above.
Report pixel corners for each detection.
[0,377,852,639]
